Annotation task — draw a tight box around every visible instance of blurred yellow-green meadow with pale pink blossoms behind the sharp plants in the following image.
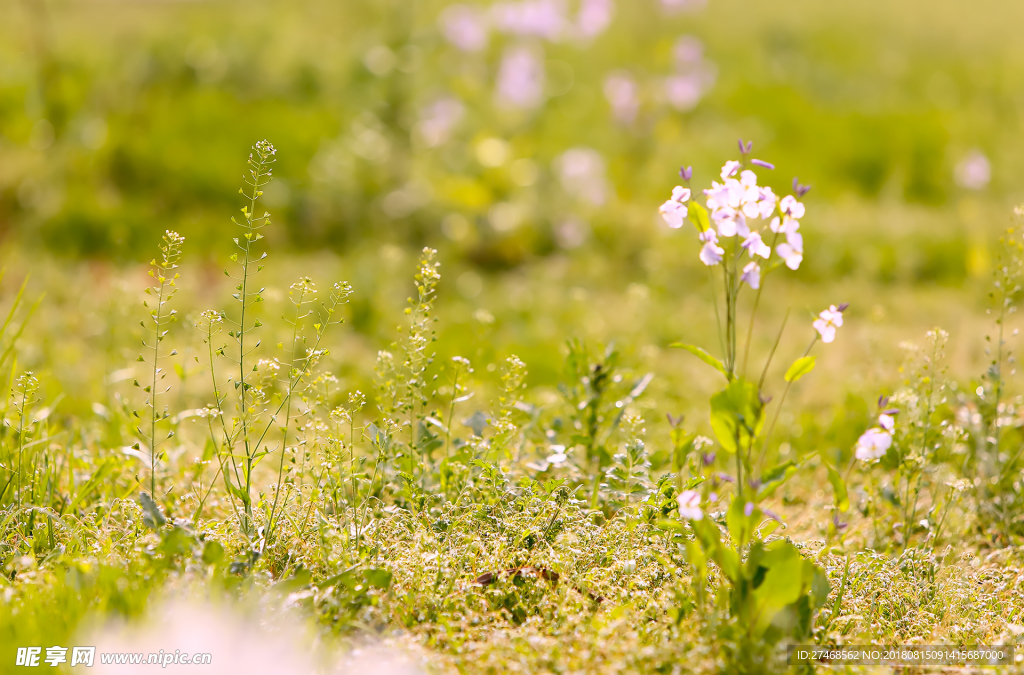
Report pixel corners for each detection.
[0,0,1024,438]
